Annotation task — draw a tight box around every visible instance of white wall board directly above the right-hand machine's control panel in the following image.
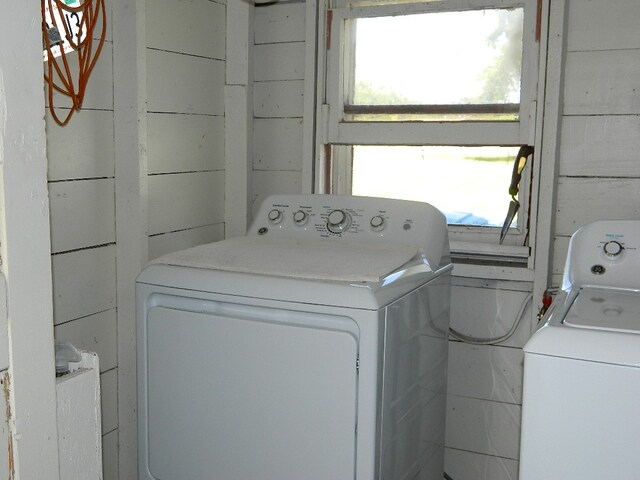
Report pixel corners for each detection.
[556,177,640,235]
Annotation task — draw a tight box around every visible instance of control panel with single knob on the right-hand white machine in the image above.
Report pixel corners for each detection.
[562,220,640,290]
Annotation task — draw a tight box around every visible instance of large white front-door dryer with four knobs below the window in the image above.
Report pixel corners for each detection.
[136,195,452,480]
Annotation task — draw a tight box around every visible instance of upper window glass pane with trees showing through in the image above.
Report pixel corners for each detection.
[348,8,523,119]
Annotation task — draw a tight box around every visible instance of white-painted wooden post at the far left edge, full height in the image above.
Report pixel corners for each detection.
[0,2,60,480]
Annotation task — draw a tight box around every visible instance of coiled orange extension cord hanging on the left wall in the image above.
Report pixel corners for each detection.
[41,0,107,126]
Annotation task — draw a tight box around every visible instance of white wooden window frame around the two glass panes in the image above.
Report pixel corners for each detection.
[316,0,544,263]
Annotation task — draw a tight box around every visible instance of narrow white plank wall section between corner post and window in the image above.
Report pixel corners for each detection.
[251,2,306,213]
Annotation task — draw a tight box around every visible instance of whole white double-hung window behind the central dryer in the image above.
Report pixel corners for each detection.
[317,0,539,258]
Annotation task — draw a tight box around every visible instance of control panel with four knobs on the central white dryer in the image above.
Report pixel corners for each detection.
[247,194,449,265]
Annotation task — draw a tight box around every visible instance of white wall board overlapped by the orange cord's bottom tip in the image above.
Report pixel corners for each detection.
[45,110,114,181]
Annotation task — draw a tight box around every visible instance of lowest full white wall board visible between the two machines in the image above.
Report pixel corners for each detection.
[446,395,522,460]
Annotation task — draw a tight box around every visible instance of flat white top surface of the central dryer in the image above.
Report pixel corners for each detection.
[151,237,420,282]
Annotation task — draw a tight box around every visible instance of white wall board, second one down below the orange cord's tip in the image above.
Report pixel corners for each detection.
[49,178,115,253]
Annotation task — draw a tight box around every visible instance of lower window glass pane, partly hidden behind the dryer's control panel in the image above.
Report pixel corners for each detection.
[351,146,518,227]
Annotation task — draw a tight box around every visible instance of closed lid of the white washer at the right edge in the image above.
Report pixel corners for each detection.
[563,288,640,333]
